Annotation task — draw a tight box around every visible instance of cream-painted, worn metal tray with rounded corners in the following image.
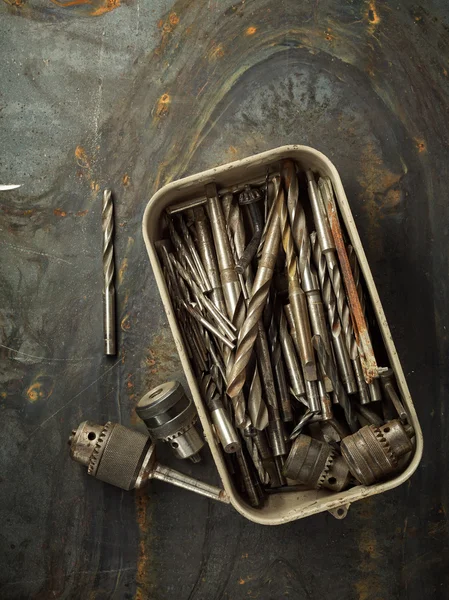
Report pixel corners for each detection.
[143,145,423,525]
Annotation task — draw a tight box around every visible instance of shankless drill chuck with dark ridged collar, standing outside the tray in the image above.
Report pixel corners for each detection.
[136,381,204,462]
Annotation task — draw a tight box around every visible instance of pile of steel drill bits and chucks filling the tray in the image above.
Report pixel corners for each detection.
[157,159,413,507]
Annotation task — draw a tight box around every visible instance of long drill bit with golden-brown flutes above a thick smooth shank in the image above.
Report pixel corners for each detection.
[278,161,317,381]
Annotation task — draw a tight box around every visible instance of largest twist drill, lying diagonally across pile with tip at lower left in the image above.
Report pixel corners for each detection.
[227,178,283,398]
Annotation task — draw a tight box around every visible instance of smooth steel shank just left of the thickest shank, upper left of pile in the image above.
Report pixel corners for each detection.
[193,206,227,314]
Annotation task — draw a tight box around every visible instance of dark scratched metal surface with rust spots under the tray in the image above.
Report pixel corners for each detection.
[0,0,449,600]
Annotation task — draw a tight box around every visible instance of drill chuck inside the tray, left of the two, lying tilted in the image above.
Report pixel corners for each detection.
[283,434,351,492]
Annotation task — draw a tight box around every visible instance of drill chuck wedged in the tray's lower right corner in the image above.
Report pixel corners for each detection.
[341,419,414,485]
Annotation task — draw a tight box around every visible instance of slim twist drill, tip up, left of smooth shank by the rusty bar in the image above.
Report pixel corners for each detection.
[310,231,358,394]
